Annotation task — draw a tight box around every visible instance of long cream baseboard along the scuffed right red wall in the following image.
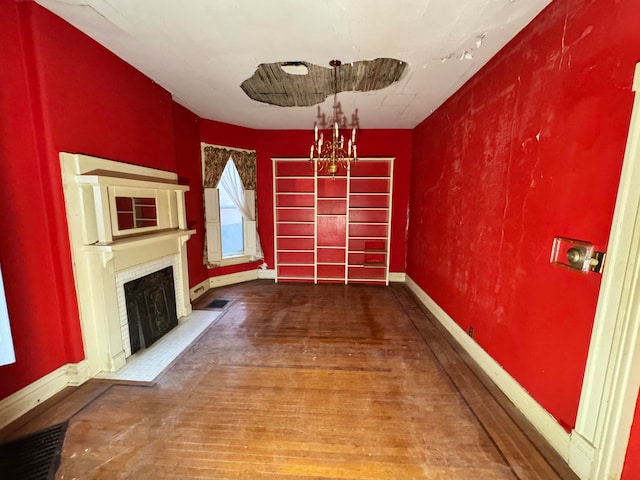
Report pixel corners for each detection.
[405,276,570,461]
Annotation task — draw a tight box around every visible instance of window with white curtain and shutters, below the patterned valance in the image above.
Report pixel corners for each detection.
[204,158,262,265]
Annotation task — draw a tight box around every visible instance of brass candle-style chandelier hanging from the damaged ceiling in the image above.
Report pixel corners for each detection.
[309,60,359,176]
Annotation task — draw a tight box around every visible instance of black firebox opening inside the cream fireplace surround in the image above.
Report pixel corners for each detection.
[124,267,178,353]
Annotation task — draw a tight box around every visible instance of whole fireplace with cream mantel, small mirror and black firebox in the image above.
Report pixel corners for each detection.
[60,153,195,376]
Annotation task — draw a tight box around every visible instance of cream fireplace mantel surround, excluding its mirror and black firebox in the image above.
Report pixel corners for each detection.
[60,153,195,376]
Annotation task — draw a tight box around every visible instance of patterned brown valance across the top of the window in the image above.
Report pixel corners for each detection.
[202,145,256,190]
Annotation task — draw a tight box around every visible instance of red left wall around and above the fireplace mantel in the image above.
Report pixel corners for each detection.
[0,1,182,398]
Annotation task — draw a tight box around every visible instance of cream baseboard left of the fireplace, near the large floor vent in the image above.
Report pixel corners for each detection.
[0,360,91,428]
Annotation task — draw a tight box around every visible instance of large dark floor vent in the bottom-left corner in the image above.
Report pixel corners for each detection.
[0,422,68,480]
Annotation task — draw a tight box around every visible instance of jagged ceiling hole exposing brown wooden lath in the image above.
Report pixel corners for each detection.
[240,58,407,107]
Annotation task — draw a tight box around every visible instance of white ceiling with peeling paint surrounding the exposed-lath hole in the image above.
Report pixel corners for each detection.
[37,0,551,129]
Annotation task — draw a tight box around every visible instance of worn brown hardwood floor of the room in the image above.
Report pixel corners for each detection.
[3,281,576,480]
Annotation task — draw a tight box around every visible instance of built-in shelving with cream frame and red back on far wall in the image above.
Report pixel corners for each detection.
[273,158,393,285]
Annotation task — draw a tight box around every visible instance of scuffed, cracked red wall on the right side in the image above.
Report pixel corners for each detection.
[407,0,640,436]
